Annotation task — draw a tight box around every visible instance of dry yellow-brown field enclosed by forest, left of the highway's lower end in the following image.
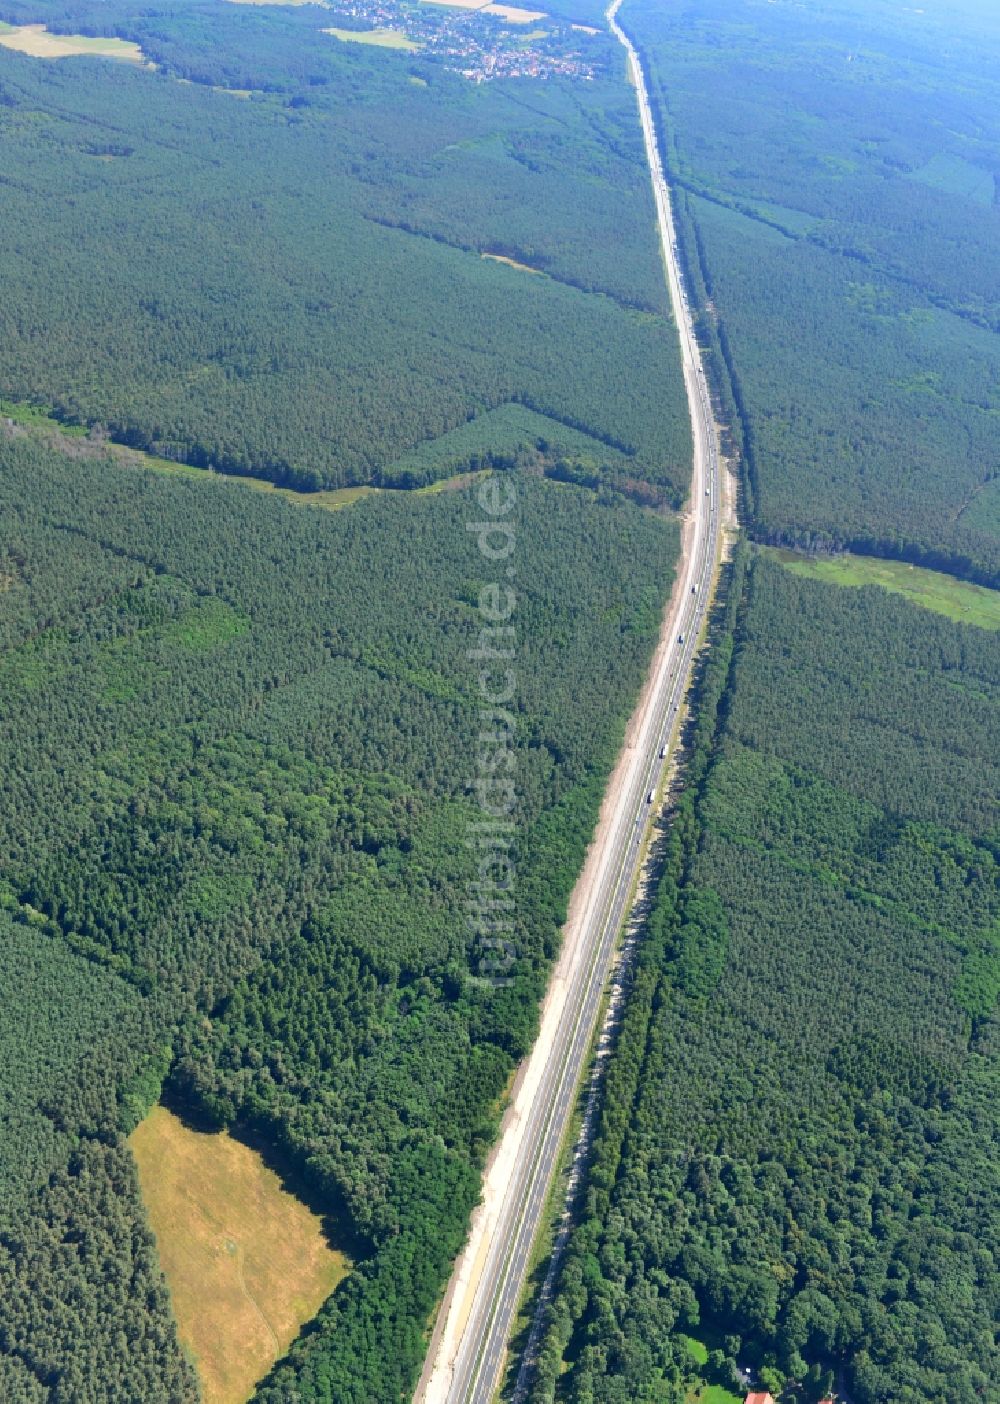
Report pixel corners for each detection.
[129,1106,351,1404]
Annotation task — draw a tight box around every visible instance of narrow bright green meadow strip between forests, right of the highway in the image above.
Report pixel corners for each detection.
[761,546,1000,629]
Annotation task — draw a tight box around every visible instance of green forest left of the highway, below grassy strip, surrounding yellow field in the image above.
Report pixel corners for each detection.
[0,430,677,1404]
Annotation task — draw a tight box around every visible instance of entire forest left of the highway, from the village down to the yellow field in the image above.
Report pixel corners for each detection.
[0,8,702,1404]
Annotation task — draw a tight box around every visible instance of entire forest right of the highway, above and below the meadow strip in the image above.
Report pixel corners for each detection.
[531,0,1000,1404]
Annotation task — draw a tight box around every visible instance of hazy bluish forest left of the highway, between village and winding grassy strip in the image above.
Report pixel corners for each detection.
[0,8,690,505]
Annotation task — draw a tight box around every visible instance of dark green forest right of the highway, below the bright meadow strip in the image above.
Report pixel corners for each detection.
[534,559,1000,1404]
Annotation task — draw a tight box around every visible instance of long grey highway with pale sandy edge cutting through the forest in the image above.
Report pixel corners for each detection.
[417,0,725,1404]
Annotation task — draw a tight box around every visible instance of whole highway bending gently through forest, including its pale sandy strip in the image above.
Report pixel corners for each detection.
[416,0,726,1404]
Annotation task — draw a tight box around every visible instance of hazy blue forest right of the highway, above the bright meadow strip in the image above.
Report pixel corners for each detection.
[626,0,1000,584]
